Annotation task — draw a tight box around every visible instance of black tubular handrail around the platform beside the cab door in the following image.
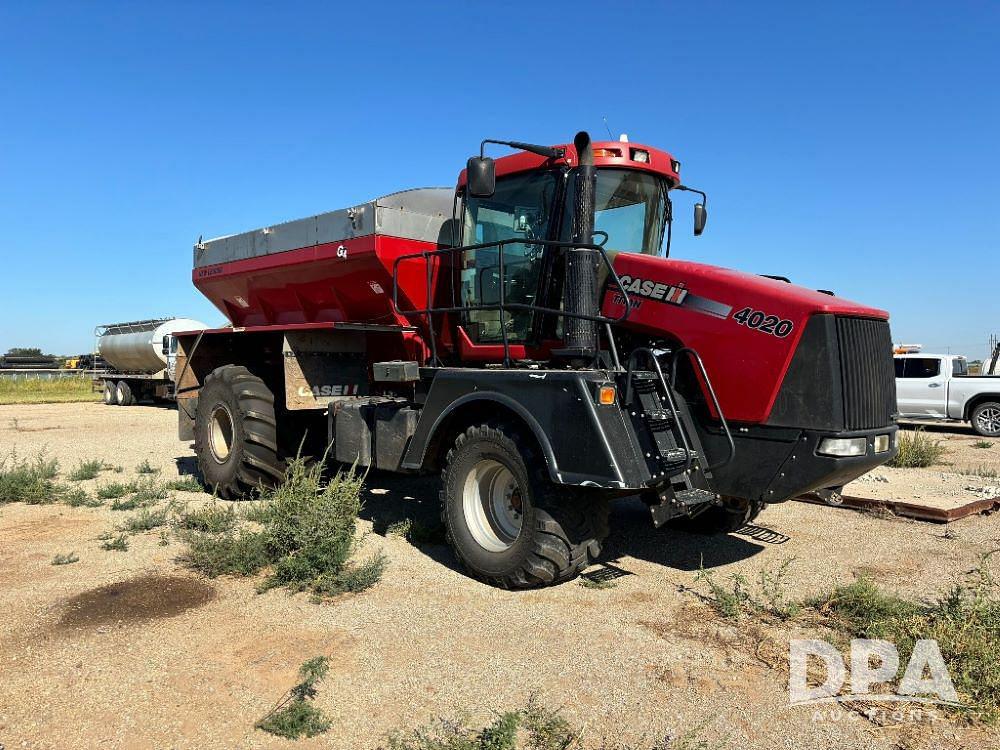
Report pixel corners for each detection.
[391,237,631,367]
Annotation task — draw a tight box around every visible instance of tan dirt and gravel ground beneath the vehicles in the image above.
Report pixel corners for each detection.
[0,404,1000,750]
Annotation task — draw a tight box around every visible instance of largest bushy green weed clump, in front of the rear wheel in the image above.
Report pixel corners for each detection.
[178,459,386,597]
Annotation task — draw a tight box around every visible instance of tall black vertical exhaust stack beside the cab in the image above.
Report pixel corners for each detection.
[558,131,599,367]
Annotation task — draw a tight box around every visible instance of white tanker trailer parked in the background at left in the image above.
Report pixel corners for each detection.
[94,318,208,406]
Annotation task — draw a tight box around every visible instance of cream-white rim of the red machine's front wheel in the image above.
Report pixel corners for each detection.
[462,459,524,552]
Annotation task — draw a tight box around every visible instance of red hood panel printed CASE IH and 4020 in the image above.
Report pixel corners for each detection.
[603,253,889,423]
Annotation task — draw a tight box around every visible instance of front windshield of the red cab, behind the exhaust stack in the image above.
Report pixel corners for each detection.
[563,169,669,255]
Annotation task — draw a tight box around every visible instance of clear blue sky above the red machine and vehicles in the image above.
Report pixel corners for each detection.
[0,0,1000,356]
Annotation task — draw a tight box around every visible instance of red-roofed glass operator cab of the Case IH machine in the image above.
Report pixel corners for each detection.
[456,141,704,347]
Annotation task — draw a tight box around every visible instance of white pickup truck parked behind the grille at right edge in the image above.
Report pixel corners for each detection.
[895,352,1000,437]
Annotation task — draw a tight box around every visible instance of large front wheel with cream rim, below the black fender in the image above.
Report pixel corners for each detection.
[441,424,608,589]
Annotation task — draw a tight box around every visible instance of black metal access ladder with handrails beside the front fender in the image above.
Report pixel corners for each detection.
[625,348,735,528]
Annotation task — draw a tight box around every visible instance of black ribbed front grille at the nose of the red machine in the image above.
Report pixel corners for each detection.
[837,317,896,430]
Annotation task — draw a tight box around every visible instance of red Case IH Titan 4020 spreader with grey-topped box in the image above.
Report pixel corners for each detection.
[177,133,896,588]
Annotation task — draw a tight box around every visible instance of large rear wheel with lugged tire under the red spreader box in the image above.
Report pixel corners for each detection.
[194,365,284,500]
